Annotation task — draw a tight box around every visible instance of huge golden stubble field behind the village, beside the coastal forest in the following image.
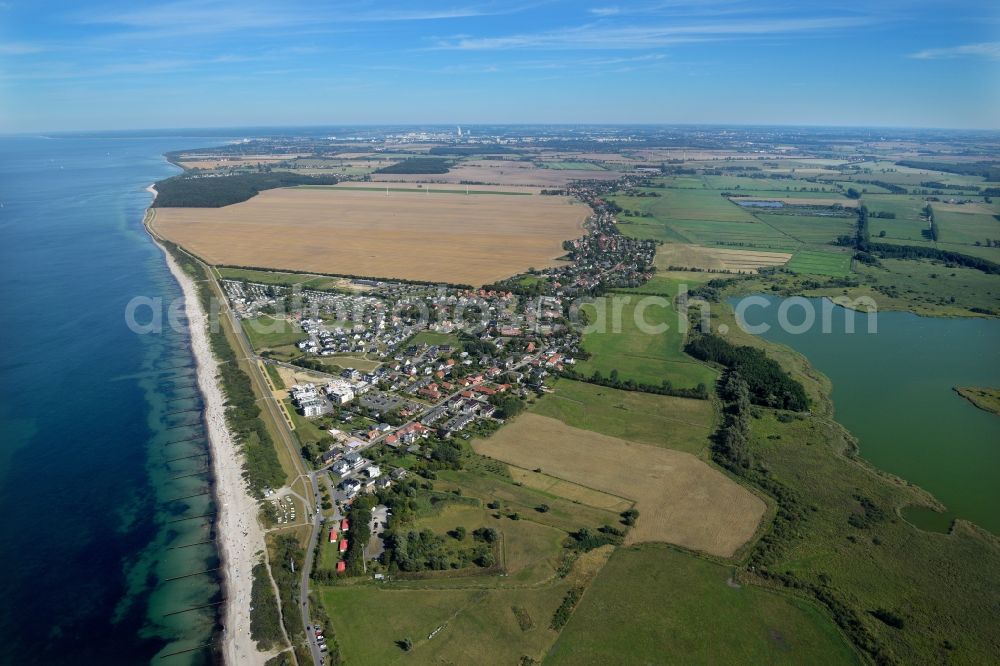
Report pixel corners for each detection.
[152,188,590,285]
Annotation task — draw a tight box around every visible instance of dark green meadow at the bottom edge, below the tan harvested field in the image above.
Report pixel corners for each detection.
[545,545,861,666]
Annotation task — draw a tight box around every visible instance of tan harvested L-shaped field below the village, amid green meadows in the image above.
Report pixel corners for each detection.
[474,414,766,557]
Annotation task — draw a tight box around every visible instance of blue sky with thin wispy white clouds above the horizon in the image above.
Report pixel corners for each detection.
[0,0,1000,133]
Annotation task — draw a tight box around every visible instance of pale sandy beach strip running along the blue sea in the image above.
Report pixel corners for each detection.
[144,185,271,665]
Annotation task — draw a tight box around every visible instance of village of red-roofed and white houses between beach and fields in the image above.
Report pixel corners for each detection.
[222,182,656,573]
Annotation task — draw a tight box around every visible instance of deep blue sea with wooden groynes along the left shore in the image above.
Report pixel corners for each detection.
[0,135,236,666]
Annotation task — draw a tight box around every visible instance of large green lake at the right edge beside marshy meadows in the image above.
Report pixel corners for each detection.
[730,297,1000,534]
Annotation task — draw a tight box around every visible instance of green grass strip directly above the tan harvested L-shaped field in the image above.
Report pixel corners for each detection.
[531,379,716,455]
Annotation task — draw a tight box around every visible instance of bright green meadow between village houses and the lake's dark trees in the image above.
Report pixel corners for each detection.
[576,295,717,388]
